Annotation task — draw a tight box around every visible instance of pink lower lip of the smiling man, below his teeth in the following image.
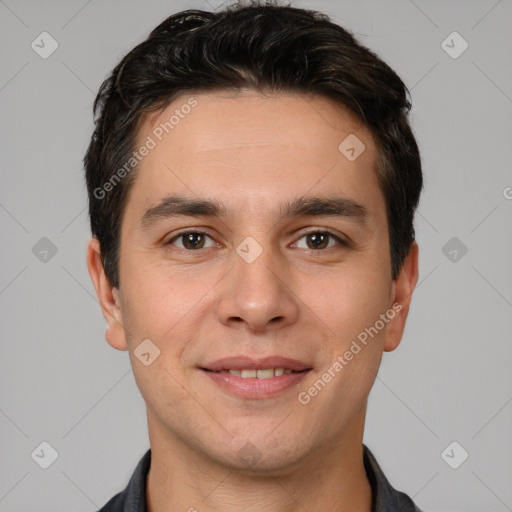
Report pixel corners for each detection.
[201,370,311,399]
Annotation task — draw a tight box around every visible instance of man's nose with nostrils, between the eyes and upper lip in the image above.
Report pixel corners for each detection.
[217,243,300,332]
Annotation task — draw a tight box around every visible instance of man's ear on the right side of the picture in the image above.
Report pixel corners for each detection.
[384,241,419,352]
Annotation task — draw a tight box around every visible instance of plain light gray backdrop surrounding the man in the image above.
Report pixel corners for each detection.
[0,0,512,512]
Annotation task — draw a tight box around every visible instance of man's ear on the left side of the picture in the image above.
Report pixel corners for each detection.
[87,238,128,350]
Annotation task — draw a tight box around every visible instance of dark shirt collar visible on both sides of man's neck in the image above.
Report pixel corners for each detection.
[99,445,421,512]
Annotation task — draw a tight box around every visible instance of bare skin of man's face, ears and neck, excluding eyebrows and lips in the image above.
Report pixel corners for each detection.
[87,90,418,512]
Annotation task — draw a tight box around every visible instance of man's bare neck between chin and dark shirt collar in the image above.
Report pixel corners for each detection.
[146,413,372,512]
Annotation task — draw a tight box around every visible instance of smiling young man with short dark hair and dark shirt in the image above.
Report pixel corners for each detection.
[84,2,422,512]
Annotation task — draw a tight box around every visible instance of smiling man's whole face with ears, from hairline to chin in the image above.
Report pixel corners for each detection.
[88,91,417,472]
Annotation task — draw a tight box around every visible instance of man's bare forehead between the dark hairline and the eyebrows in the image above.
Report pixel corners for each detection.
[131,90,383,220]
